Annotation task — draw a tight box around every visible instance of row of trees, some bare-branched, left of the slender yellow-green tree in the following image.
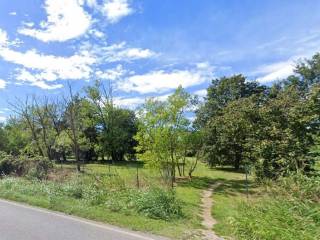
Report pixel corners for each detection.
[0,82,137,171]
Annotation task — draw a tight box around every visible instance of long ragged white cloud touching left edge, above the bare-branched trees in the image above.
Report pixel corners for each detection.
[0,29,96,89]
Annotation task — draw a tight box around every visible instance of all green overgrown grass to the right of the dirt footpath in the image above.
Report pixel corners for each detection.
[213,169,320,240]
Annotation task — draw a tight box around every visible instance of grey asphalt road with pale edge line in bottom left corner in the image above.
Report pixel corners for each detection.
[0,200,170,240]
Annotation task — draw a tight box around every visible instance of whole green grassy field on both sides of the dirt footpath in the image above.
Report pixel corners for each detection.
[0,160,320,240]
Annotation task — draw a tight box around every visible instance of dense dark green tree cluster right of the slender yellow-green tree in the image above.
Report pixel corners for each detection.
[195,54,320,178]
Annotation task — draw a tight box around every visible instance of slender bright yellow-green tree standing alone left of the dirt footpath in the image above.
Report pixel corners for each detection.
[135,87,192,186]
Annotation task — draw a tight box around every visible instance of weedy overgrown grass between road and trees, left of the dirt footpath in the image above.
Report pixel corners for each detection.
[0,164,210,239]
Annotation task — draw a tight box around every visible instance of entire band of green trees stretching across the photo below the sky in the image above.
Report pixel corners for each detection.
[0,54,320,180]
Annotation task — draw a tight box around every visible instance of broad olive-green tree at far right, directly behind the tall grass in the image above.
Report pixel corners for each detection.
[253,85,319,178]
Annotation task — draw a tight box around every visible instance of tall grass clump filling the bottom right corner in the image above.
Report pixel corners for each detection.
[232,175,320,240]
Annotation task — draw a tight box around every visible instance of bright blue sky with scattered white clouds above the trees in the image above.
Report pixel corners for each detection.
[0,0,320,121]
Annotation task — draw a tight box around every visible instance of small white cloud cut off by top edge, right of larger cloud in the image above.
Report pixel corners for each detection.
[101,0,133,23]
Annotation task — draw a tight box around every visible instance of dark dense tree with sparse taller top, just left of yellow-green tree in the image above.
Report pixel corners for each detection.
[86,82,137,161]
